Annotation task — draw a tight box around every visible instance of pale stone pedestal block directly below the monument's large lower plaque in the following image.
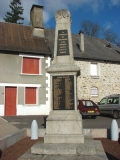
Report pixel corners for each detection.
[44,110,84,144]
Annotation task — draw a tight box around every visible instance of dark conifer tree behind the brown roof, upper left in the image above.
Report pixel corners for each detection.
[3,0,24,24]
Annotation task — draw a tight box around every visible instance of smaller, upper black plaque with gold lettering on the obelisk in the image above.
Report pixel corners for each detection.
[57,30,69,56]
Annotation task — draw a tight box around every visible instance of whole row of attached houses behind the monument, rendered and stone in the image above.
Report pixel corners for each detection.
[0,5,120,116]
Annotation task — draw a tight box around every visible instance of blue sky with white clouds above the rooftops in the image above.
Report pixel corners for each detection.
[0,0,120,39]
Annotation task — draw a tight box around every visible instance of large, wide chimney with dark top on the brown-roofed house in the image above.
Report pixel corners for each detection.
[30,5,44,37]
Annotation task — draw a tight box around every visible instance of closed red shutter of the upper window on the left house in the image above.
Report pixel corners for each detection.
[22,57,40,74]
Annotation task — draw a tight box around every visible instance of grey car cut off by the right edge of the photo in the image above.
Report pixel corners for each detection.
[98,94,120,119]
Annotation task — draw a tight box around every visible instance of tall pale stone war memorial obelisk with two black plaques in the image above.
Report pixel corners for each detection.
[44,9,84,144]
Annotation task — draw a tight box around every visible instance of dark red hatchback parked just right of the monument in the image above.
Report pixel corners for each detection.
[78,100,100,118]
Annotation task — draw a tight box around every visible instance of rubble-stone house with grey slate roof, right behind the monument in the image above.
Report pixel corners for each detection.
[46,30,120,102]
